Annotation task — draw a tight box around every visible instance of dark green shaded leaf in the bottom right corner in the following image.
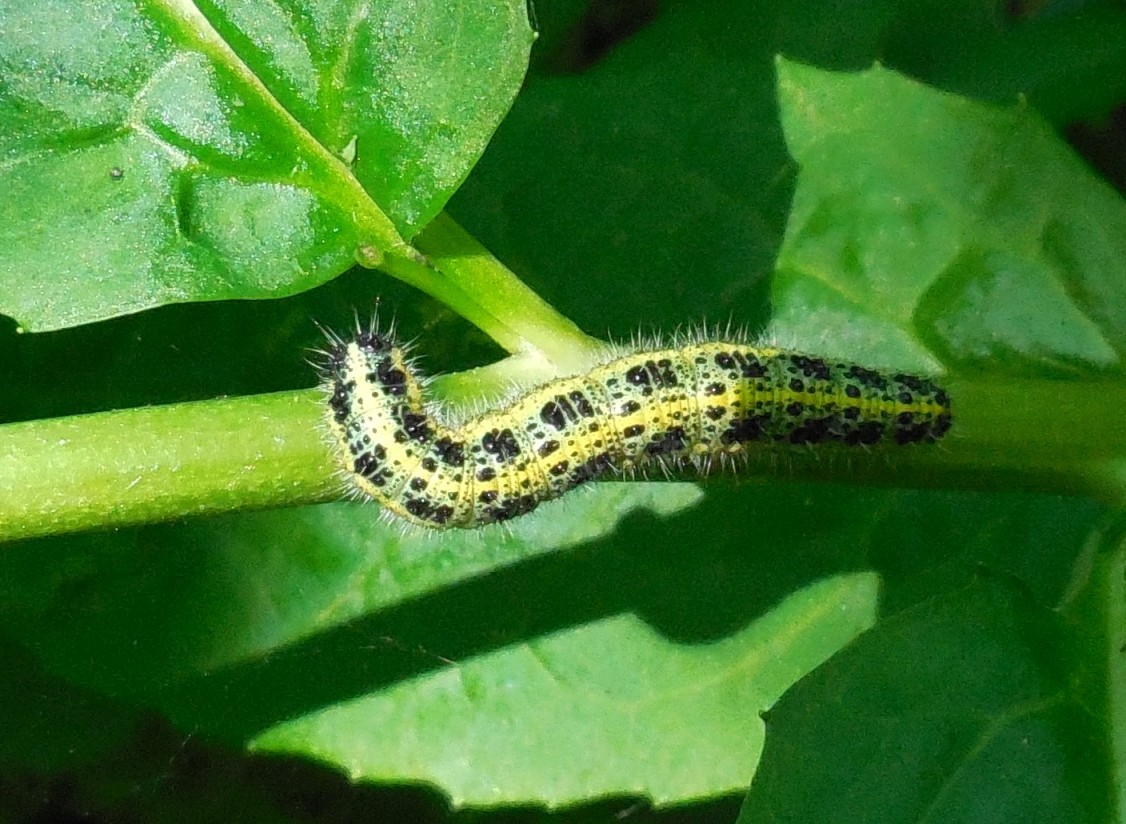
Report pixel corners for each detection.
[740,571,1112,824]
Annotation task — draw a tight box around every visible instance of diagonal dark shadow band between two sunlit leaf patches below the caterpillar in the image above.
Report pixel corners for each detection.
[157,484,900,742]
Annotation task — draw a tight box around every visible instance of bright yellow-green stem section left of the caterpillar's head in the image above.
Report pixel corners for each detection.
[0,389,333,541]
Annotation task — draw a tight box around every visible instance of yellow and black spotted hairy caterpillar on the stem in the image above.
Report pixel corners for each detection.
[323,329,951,529]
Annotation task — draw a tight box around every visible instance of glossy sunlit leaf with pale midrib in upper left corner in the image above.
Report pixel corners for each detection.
[0,0,531,330]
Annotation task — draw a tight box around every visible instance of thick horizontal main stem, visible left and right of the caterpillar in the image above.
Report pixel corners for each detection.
[0,379,1126,541]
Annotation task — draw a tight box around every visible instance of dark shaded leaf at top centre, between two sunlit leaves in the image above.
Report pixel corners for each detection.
[449,3,794,340]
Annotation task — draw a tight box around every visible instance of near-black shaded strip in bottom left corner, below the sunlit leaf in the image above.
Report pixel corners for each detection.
[0,636,740,824]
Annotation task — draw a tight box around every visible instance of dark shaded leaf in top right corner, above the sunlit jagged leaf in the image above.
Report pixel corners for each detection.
[778,0,1126,127]
